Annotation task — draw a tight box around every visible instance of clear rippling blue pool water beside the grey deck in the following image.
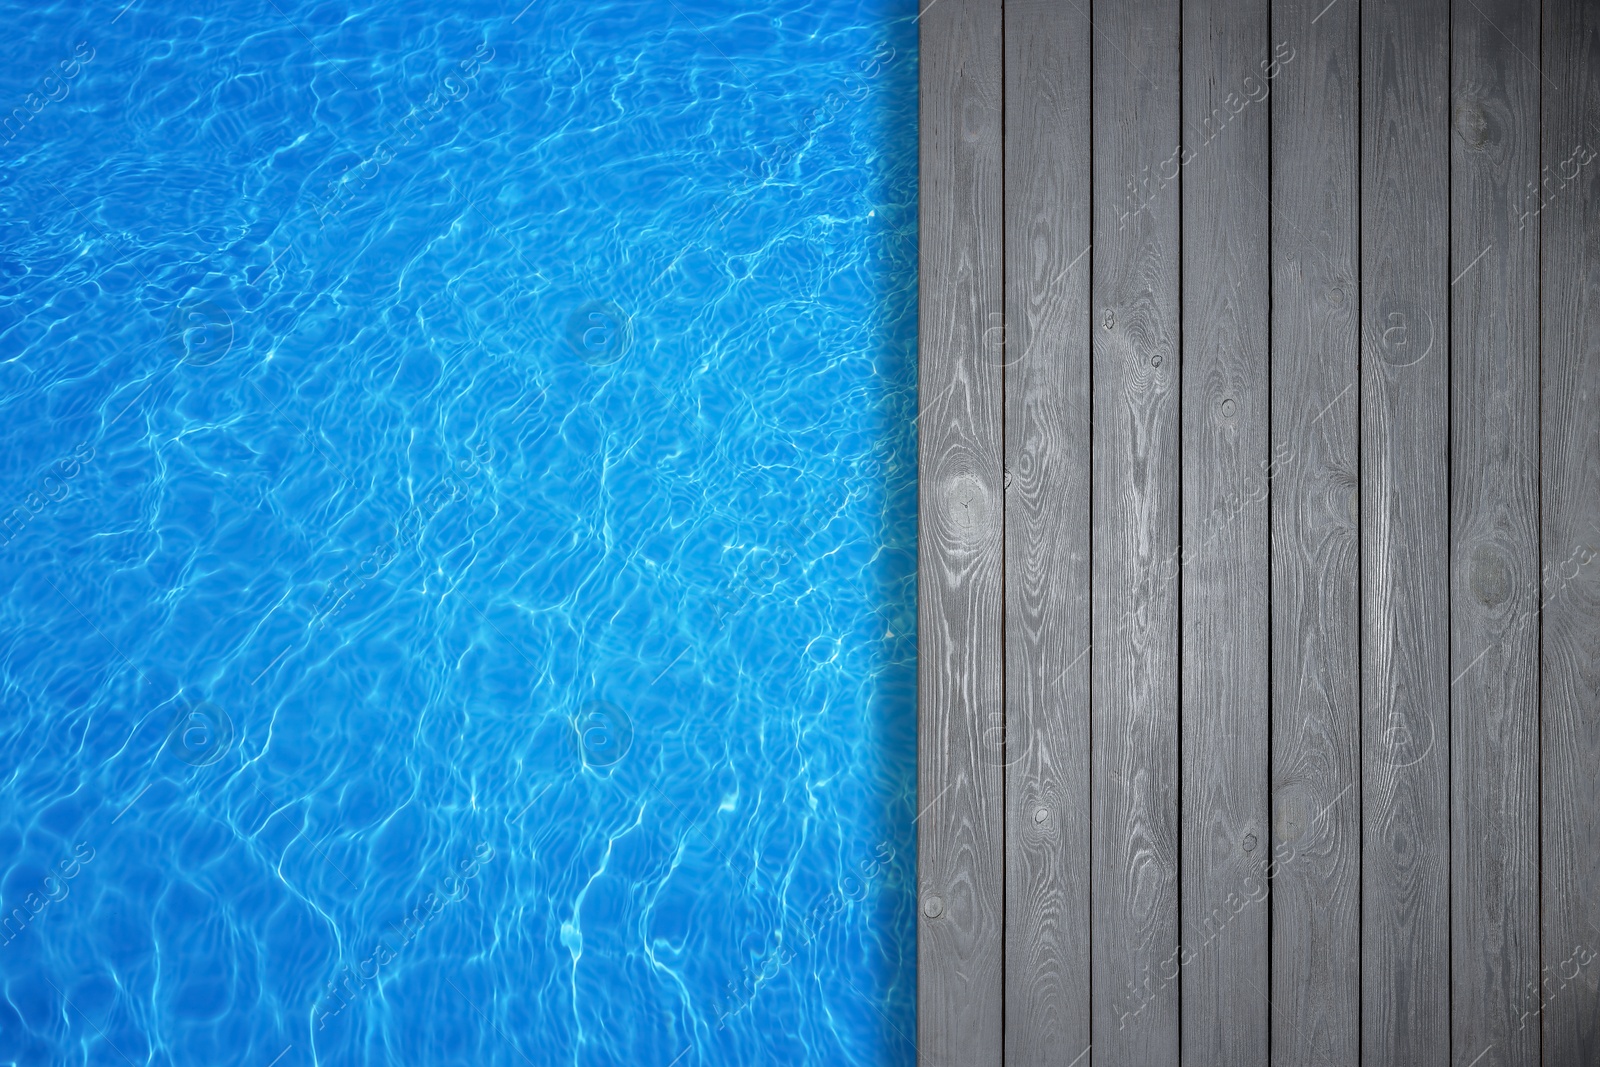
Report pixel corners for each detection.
[0,0,917,1067]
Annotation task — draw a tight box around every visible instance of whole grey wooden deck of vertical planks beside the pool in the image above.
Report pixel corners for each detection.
[918,0,1600,1067]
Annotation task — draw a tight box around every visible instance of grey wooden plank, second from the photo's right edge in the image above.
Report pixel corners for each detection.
[1450,0,1541,1067]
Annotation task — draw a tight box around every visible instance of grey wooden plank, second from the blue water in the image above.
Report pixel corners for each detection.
[1005,0,1091,1067]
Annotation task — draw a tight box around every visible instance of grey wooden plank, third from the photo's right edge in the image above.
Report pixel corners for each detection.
[1362,0,1450,1067]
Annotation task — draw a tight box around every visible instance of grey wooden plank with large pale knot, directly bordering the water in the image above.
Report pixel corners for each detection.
[917,0,1005,1067]
